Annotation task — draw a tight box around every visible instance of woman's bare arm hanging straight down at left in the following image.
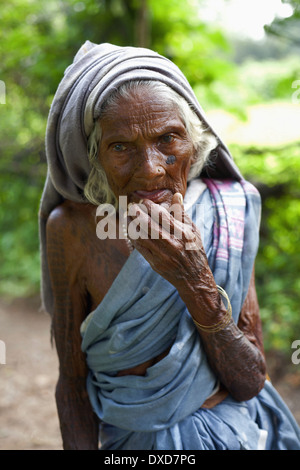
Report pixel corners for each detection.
[47,207,99,450]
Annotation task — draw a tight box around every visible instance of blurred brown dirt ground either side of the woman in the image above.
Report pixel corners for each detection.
[0,299,300,450]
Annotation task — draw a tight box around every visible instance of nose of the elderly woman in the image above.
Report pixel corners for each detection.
[135,147,165,179]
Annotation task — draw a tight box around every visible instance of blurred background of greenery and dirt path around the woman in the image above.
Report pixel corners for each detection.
[0,0,300,449]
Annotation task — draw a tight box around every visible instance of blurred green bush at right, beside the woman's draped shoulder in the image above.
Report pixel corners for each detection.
[232,142,300,355]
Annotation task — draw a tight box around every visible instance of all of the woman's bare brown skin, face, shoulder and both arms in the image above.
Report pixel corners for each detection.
[47,90,265,449]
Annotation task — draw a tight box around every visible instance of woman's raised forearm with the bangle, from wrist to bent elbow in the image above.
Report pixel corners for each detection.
[177,281,266,401]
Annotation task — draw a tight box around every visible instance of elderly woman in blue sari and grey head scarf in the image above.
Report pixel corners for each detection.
[40,42,300,450]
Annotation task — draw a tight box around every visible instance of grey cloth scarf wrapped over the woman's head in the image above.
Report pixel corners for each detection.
[39,41,241,314]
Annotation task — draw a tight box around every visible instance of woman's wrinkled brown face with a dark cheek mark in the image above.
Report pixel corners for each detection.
[99,89,194,204]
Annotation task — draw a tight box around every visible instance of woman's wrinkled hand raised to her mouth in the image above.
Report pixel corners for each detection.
[128,193,212,289]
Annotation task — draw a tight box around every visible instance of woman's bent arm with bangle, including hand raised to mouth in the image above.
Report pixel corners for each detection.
[132,195,266,401]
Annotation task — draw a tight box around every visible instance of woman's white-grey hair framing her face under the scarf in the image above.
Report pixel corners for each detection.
[84,80,218,207]
